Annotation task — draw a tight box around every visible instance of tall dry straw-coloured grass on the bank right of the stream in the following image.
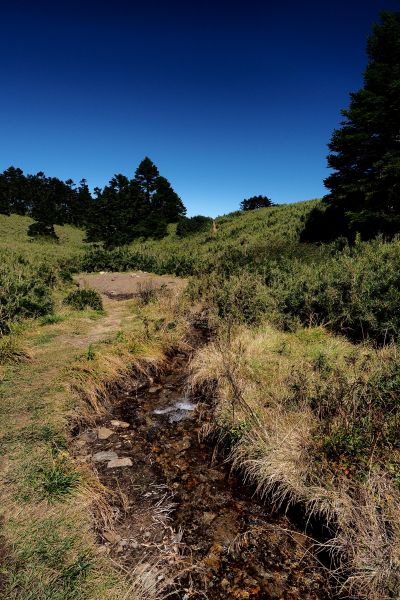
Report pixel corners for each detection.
[191,325,400,600]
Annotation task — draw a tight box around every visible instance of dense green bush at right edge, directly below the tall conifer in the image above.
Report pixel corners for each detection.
[266,239,400,343]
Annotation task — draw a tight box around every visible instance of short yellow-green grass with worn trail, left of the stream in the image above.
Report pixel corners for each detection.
[0,286,192,600]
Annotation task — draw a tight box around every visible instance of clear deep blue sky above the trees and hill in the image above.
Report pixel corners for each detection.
[0,0,400,215]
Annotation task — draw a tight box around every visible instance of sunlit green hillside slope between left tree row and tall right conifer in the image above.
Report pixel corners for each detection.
[83,200,318,275]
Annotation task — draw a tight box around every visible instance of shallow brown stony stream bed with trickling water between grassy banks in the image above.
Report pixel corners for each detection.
[75,338,334,600]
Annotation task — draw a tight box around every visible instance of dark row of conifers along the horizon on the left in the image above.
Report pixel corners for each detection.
[0,157,186,247]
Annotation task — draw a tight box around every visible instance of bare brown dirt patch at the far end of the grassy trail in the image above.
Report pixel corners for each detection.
[77,271,185,300]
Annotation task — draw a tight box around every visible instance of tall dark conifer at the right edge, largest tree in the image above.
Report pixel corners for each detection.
[302,12,400,241]
